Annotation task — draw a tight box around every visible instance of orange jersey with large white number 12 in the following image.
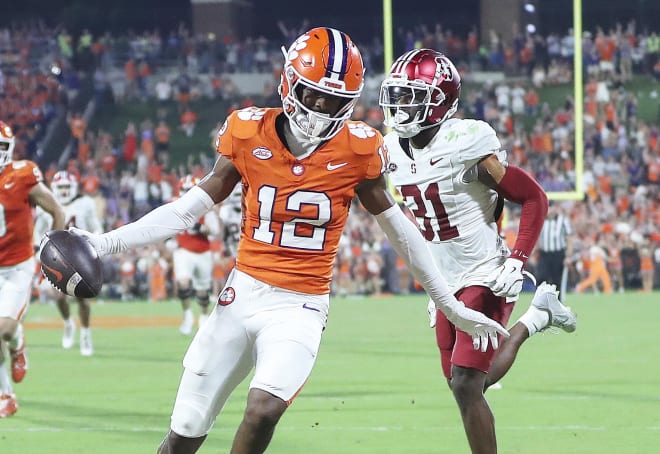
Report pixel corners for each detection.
[216,107,387,294]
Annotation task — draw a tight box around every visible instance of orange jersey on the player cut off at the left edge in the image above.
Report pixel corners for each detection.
[0,161,43,266]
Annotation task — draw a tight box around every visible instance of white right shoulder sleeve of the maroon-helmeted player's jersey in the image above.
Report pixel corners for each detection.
[456,120,506,168]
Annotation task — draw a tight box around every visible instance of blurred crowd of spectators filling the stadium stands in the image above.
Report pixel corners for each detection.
[0,18,660,300]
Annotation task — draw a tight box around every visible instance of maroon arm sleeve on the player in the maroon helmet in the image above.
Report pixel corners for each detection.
[496,165,548,264]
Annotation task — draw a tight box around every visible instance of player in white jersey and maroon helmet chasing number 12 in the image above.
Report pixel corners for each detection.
[379,49,576,454]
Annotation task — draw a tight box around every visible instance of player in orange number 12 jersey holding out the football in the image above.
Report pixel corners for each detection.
[68,27,508,453]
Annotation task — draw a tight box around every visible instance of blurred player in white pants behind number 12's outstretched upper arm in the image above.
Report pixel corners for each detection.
[172,175,220,336]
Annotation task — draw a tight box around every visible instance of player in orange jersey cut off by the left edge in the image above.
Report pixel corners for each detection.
[0,121,64,418]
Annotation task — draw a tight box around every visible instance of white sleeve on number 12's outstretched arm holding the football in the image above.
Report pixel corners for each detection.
[97,186,214,255]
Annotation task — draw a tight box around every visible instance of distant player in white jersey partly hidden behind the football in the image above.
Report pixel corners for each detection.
[50,170,103,356]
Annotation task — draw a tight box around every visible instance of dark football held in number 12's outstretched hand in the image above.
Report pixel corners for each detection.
[39,230,103,298]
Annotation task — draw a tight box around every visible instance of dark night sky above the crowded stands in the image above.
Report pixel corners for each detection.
[6,0,660,40]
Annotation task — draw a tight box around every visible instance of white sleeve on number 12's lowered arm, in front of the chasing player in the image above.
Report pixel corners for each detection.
[376,205,464,321]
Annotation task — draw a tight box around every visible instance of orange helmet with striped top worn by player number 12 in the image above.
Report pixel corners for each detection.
[278,27,364,142]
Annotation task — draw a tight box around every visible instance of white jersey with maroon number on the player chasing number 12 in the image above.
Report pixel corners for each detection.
[385,119,509,293]
